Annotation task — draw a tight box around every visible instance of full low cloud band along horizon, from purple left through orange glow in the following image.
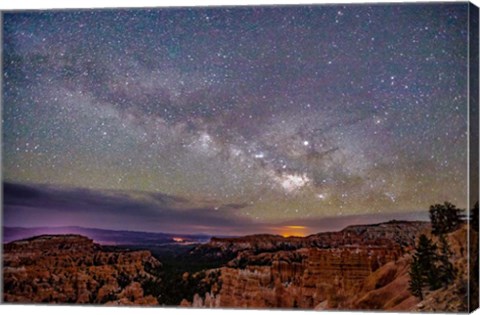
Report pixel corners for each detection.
[3,182,428,235]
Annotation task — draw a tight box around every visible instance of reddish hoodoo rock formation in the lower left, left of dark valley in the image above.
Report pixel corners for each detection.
[3,235,161,305]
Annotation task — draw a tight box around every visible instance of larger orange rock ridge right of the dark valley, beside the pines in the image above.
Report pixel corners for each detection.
[183,221,429,309]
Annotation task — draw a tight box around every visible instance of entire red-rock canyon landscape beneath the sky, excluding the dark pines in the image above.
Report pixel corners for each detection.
[3,221,477,312]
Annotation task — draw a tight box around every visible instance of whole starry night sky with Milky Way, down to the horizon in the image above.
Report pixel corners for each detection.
[2,3,468,234]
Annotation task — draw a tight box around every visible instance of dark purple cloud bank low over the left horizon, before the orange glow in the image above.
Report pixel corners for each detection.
[3,182,255,233]
